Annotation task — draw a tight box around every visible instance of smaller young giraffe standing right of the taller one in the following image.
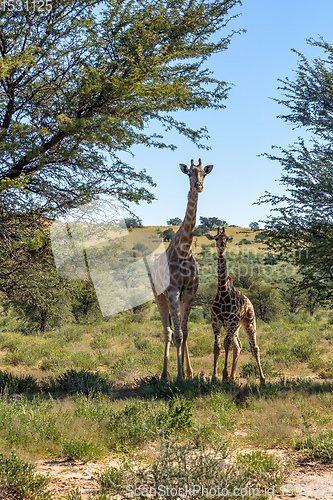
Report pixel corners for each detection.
[205,228,265,384]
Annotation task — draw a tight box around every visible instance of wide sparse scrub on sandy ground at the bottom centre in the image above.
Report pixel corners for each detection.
[96,441,293,499]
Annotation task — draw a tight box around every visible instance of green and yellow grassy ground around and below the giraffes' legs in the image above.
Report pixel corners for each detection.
[0,309,333,500]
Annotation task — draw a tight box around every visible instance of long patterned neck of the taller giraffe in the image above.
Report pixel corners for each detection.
[174,189,198,257]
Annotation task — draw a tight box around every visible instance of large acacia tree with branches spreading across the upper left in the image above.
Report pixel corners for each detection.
[0,0,244,316]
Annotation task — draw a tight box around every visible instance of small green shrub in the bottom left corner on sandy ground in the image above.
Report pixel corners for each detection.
[0,452,51,500]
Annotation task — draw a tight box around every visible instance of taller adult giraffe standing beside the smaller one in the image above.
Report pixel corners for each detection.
[152,158,213,380]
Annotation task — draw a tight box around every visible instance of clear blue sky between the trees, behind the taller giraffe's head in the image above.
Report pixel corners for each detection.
[123,0,333,227]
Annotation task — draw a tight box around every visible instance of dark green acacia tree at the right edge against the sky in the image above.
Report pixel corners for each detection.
[259,40,333,306]
